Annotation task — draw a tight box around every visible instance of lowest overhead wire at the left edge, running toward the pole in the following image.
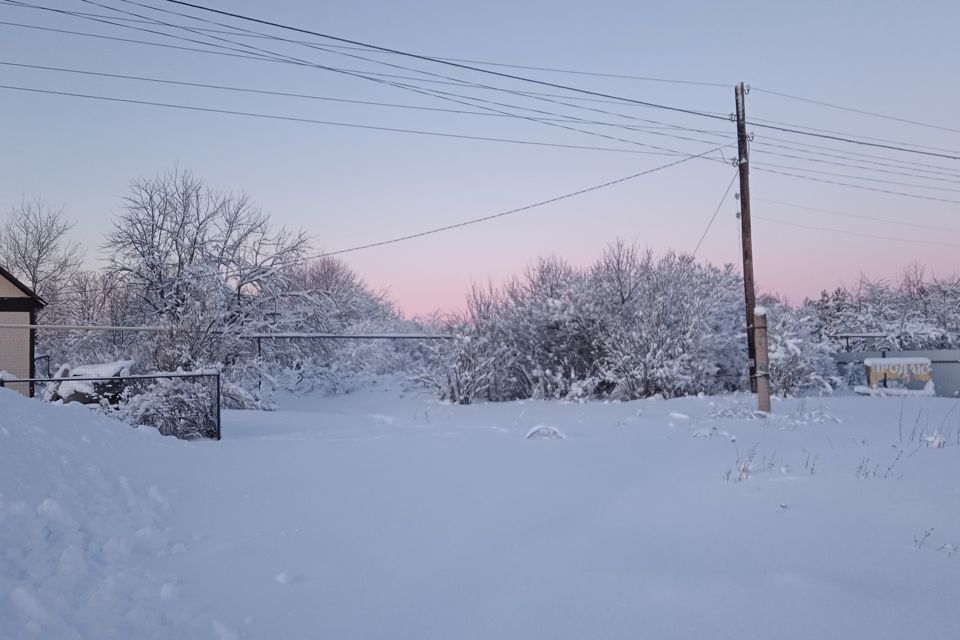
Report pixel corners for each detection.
[0,84,708,156]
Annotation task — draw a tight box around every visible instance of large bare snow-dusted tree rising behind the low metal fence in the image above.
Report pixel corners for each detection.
[103,169,307,369]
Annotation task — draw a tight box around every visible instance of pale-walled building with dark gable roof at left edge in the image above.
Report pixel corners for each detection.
[0,267,47,395]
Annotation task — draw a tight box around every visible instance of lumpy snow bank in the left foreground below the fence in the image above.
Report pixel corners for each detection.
[0,389,212,639]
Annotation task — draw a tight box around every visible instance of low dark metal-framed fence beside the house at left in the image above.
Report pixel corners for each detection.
[0,372,221,440]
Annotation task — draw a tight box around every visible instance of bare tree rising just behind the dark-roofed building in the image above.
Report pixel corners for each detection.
[0,198,83,302]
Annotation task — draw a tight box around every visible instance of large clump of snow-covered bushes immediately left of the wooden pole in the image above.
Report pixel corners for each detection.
[418,243,746,403]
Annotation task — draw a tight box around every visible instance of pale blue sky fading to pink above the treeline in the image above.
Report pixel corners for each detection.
[0,0,960,315]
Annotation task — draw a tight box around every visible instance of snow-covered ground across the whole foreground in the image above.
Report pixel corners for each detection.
[0,384,960,640]
